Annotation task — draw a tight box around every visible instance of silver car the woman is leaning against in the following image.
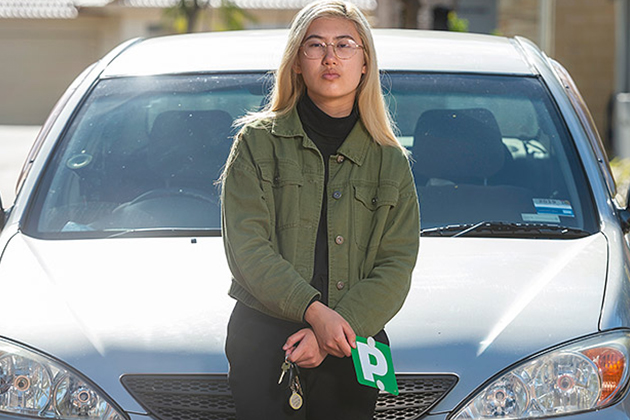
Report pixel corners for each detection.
[0,30,630,420]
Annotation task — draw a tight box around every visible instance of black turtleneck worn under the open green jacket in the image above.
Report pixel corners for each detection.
[297,95,359,305]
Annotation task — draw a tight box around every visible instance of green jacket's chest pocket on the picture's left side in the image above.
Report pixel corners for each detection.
[260,162,304,229]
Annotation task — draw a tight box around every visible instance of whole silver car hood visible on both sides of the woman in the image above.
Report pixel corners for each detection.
[0,234,607,412]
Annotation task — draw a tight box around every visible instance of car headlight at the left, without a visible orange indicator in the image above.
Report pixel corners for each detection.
[0,339,127,420]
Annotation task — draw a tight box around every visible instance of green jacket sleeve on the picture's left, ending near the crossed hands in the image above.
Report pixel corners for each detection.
[221,130,319,322]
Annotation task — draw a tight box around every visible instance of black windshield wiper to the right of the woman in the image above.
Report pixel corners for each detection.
[421,221,590,239]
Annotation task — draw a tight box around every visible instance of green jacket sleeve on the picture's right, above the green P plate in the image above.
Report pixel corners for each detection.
[335,159,420,337]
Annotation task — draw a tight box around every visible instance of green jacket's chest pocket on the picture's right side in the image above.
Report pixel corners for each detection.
[352,185,398,250]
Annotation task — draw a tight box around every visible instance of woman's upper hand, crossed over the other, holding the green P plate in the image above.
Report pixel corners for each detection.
[304,302,357,357]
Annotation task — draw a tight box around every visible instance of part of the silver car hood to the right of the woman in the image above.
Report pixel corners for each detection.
[387,233,608,409]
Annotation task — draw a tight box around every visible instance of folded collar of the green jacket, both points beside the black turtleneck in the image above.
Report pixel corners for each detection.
[271,107,373,166]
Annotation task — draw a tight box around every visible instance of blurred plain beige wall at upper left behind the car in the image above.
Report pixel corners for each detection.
[0,19,100,125]
